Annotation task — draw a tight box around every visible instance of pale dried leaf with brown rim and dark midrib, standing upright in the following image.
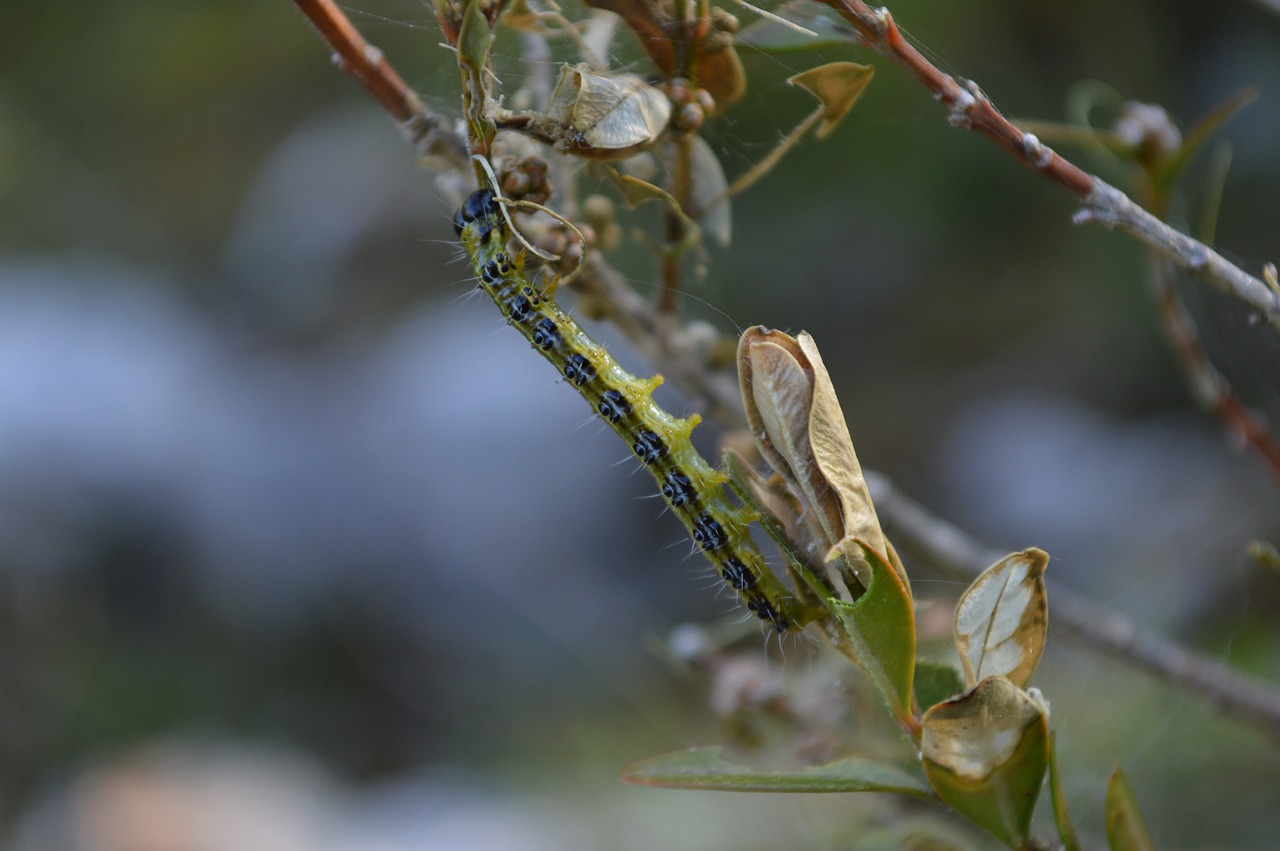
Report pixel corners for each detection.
[954,548,1048,686]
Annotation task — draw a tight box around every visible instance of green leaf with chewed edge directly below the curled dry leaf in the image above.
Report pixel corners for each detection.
[819,539,915,719]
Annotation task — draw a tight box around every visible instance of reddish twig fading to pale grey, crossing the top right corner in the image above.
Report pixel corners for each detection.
[815,0,1280,329]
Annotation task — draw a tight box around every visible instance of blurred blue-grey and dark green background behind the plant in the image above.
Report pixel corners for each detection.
[0,0,1280,851]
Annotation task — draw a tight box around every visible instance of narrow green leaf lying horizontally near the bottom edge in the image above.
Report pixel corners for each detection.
[622,747,929,799]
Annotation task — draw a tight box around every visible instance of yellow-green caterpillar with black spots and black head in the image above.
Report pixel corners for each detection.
[453,189,809,632]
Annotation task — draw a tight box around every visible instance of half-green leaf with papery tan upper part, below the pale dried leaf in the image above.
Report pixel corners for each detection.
[920,677,1048,846]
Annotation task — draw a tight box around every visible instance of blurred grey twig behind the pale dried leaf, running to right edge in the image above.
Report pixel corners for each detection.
[867,471,1280,742]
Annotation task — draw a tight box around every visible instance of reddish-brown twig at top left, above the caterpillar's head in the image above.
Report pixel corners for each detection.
[293,0,470,170]
